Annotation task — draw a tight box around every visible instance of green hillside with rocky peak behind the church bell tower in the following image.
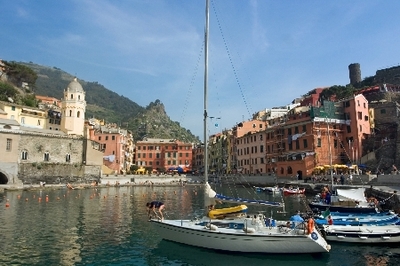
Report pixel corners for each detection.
[18,62,200,143]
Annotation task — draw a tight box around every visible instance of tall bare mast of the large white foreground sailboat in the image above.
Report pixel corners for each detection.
[203,0,210,183]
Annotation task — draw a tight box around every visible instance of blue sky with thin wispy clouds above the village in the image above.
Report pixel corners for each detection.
[0,0,400,141]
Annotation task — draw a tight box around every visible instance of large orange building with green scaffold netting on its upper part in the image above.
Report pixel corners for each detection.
[266,95,370,179]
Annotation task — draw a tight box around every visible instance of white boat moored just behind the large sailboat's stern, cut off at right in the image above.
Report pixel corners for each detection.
[322,225,400,244]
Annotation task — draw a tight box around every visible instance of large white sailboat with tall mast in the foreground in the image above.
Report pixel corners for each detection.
[150,0,330,254]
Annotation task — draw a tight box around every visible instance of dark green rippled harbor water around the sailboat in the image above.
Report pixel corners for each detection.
[0,185,400,266]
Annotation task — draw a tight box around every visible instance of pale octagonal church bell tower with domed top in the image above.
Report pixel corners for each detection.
[61,78,86,136]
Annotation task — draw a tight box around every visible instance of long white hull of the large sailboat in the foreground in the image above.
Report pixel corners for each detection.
[151,219,330,254]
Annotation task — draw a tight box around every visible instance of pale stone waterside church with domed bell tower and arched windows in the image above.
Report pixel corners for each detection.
[0,78,103,185]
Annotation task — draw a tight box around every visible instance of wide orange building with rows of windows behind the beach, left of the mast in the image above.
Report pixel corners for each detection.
[135,138,193,172]
